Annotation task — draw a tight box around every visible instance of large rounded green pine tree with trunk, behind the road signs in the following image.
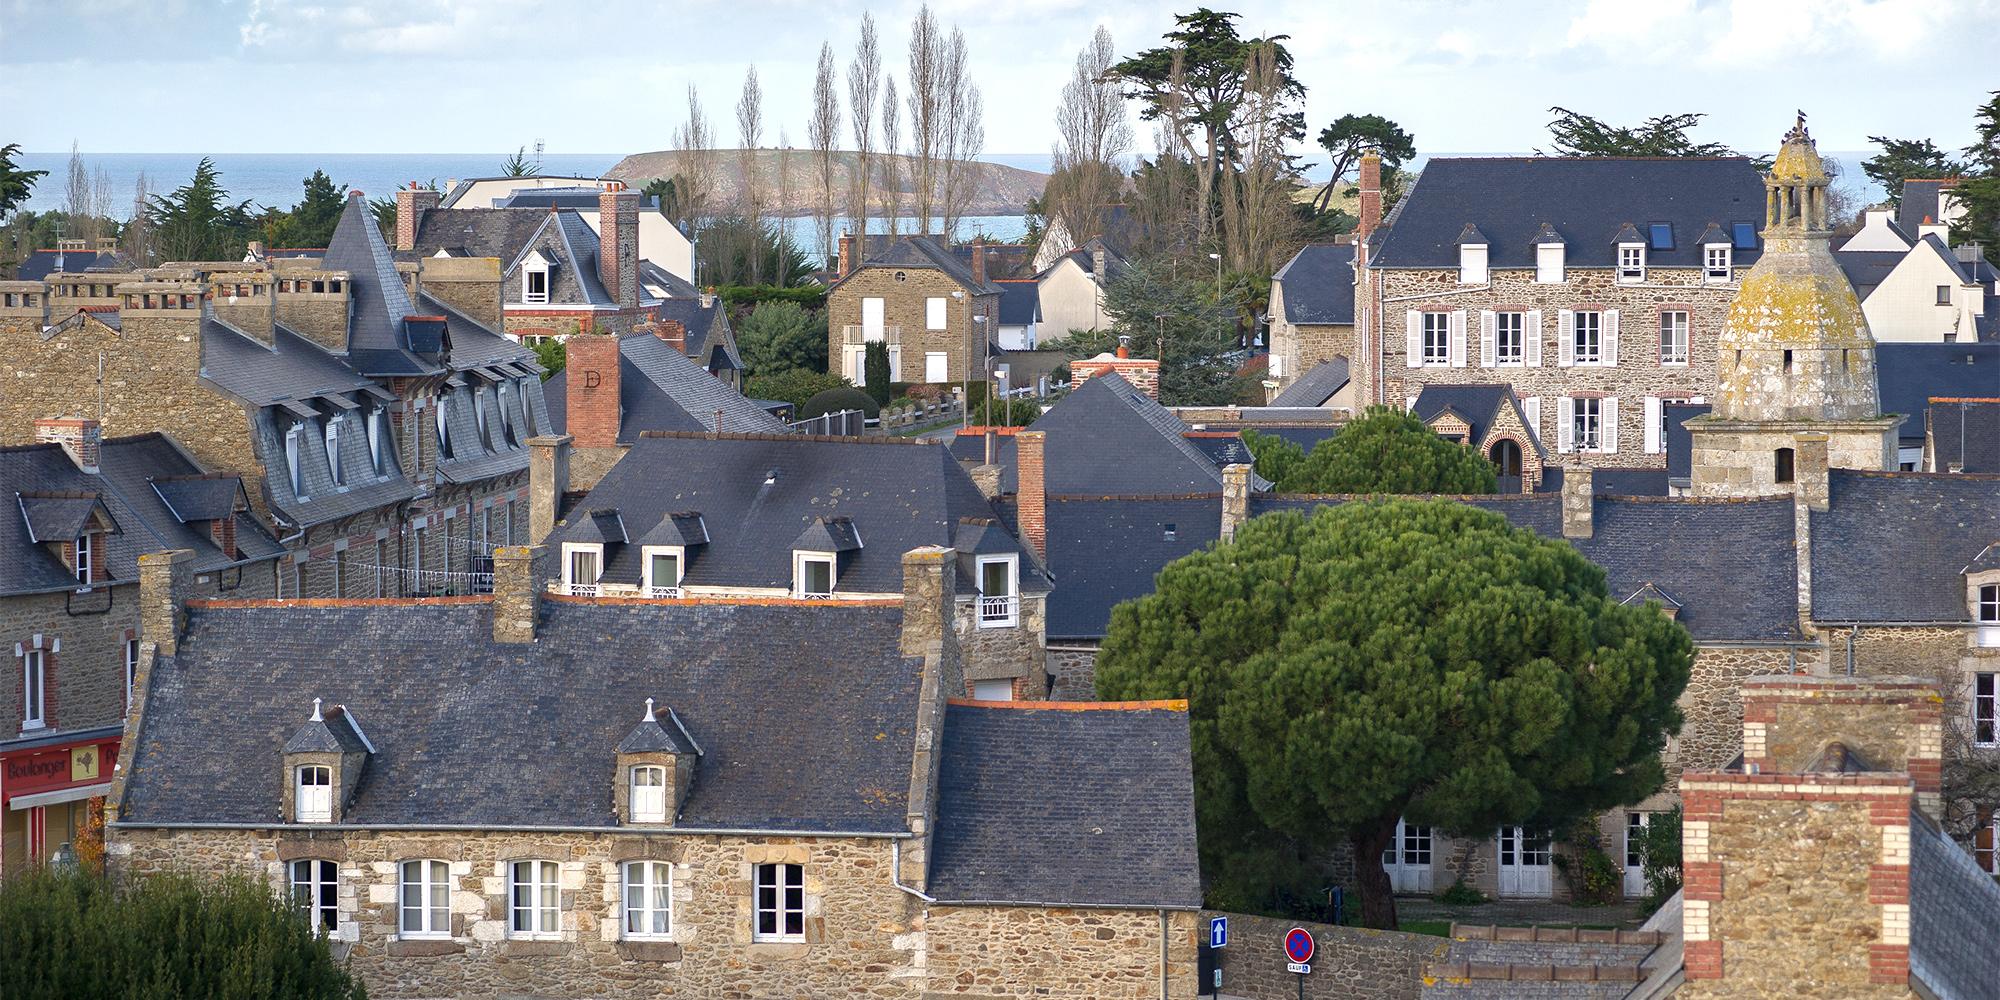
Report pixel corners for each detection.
[1096,500,1694,928]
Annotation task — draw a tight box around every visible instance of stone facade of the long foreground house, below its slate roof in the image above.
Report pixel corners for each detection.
[110,828,1194,1000]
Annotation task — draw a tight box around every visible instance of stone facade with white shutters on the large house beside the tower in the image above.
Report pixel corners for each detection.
[1354,268,1736,468]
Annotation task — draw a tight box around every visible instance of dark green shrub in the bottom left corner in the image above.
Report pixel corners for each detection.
[0,868,368,1000]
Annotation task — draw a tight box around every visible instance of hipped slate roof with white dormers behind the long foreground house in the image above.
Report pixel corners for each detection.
[548,434,1048,592]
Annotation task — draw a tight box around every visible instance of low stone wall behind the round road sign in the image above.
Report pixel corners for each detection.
[1200,910,1450,1000]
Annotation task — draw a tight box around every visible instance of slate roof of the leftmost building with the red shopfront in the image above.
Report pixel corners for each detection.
[0,434,282,594]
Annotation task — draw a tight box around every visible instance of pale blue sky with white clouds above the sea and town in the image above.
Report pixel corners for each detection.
[0,0,2000,154]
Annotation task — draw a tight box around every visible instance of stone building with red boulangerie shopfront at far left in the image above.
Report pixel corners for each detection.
[0,430,284,878]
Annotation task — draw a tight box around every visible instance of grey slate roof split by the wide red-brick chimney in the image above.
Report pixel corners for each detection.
[542,332,786,444]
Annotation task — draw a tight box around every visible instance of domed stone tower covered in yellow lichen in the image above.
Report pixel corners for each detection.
[1688,114,1902,496]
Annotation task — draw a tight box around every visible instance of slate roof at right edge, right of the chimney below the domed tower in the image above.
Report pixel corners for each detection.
[1812,468,2000,622]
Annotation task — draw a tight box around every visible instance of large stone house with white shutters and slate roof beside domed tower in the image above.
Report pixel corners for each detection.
[1350,156,1762,466]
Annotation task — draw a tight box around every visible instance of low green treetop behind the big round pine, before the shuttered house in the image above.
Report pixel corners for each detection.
[1244,406,1498,494]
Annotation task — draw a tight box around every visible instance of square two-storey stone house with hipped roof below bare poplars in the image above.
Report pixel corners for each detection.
[826,236,1000,384]
